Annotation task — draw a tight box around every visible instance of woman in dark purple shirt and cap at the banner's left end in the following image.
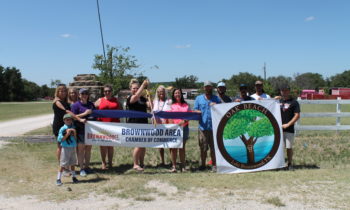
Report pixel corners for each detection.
[72,88,95,176]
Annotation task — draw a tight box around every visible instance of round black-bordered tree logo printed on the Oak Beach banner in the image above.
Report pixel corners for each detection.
[217,103,281,169]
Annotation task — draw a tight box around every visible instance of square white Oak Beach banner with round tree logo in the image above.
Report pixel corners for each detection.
[211,100,285,173]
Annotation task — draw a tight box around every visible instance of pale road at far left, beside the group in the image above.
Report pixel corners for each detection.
[0,114,53,136]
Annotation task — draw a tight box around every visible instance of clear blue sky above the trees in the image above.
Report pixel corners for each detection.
[0,0,350,85]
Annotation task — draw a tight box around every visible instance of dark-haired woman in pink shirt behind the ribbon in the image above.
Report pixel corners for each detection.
[170,88,191,172]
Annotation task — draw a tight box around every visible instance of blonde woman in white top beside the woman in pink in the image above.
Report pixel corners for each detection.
[152,85,171,166]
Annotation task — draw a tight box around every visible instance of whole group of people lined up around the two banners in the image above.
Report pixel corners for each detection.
[53,79,300,185]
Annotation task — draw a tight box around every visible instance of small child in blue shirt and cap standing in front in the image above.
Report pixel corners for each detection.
[56,114,78,186]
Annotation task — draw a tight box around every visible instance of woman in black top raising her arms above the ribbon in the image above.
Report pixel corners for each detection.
[126,79,149,172]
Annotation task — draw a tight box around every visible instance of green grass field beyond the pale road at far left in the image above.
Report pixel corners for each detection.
[0,102,53,121]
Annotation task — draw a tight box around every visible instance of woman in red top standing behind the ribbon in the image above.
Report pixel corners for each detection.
[95,85,123,170]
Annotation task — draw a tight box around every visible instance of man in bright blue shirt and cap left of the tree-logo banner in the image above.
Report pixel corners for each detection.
[193,81,221,171]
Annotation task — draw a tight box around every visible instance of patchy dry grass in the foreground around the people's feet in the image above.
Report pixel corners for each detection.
[0,132,350,208]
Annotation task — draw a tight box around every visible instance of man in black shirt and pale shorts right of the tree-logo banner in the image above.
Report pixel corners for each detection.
[280,85,300,170]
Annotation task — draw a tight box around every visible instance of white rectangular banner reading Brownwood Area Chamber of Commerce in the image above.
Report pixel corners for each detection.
[85,121,183,148]
